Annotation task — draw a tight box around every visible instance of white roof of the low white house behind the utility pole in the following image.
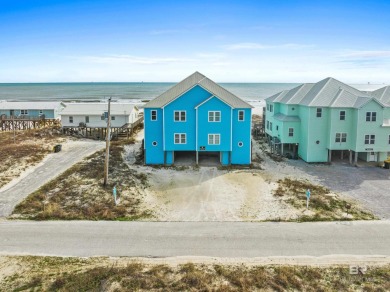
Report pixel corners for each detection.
[60,102,137,116]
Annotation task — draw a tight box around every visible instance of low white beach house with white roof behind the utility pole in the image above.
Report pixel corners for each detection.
[61,102,138,128]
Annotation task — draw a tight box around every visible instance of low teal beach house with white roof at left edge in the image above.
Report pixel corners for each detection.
[0,101,64,119]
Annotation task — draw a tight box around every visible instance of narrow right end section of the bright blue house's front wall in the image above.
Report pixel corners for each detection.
[231,109,252,164]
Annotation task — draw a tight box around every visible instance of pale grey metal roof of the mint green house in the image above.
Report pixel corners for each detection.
[266,77,390,108]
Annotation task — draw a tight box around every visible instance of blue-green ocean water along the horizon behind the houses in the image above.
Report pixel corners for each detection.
[0,82,384,107]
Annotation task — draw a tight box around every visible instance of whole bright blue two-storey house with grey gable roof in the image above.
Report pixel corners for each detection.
[144,72,252,165]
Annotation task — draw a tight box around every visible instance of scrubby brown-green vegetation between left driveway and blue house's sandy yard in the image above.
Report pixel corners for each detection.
[11,124,151,220]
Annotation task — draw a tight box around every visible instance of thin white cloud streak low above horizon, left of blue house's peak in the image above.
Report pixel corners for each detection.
[70,55,193,65]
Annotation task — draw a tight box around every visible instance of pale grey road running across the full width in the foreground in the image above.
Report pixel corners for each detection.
[0,220,390,258]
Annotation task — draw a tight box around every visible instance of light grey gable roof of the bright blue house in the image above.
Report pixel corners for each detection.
[144,72,253,108]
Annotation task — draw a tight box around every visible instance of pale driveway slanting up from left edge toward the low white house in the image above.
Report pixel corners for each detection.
[0,141,105,217]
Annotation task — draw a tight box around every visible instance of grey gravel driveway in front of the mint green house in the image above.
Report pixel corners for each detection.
[288,160,390,219]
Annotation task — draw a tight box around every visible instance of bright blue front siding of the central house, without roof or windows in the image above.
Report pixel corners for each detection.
[144,85,251,165]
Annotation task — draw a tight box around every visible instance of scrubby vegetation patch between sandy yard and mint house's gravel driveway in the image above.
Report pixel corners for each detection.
[274,178,375,222]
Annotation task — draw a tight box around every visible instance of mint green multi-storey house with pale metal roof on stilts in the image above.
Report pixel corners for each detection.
[264,78,390,165]
